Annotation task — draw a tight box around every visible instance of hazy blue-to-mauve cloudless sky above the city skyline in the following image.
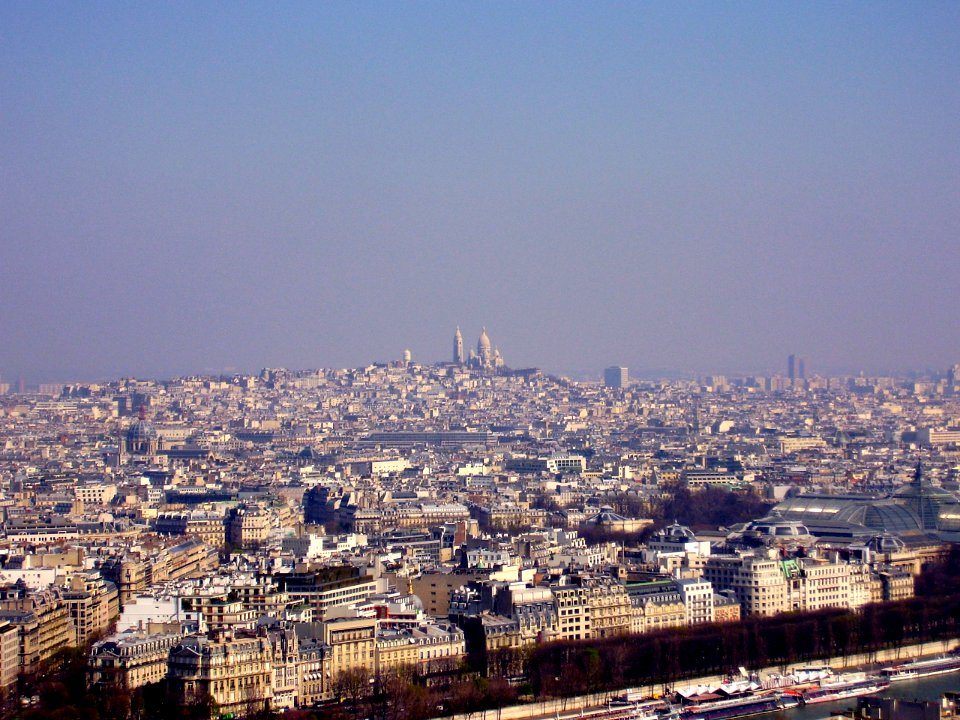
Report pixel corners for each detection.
[0,0,960,380]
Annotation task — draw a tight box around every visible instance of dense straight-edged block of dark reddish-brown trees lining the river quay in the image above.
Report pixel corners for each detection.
[527,595,960,696]
